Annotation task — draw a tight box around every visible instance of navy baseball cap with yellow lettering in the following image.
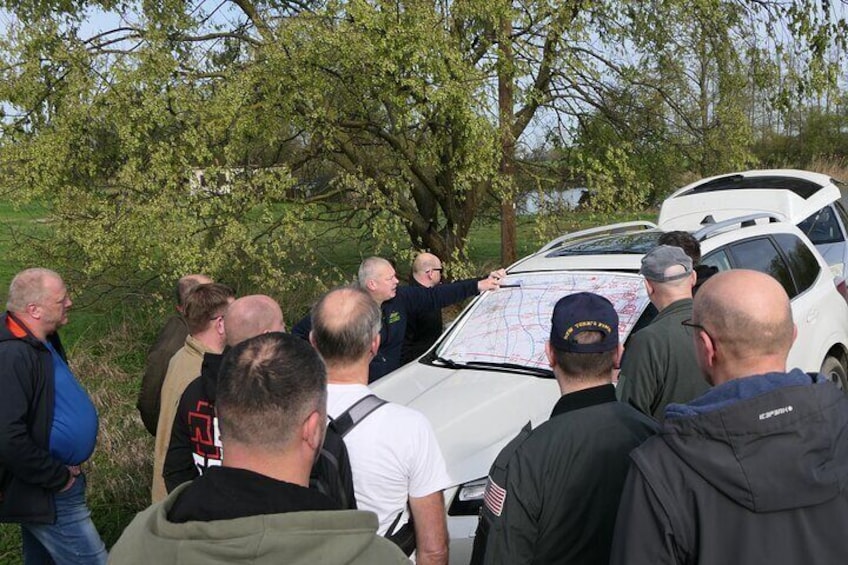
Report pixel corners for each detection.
[551,292,618,353]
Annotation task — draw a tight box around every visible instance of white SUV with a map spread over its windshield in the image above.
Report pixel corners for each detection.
[373,214,848,563]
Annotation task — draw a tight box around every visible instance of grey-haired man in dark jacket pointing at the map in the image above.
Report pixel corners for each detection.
[292,257,506,383]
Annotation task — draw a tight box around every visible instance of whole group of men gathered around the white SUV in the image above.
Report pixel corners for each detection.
[0,232,848,565]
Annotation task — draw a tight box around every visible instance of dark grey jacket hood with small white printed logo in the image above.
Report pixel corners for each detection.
[661,371,848,512]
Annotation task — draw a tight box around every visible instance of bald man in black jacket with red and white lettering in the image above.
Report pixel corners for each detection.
[162,294,286,492]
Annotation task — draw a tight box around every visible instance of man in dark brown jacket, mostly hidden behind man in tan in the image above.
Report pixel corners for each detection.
[136,274,212,436]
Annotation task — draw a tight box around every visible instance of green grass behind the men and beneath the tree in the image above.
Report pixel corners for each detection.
[0,199,655,564]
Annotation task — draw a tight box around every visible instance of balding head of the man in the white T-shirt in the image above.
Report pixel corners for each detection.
[312,287,381,364]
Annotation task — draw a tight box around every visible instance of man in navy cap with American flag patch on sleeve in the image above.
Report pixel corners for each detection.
[472,292,657,565]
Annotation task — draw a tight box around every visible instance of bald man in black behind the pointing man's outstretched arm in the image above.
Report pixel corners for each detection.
[400,253,444,365]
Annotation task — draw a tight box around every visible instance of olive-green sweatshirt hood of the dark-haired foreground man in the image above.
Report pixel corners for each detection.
[110,484,394,565]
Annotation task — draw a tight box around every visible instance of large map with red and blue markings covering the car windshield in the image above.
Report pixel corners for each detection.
[436,271,648,370]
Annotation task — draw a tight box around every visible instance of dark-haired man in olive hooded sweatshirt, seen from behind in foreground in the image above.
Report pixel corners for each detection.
[109,333,408,565]
